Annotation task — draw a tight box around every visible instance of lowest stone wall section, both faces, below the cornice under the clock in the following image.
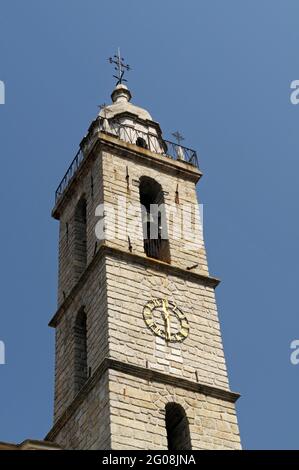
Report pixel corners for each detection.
[49,370,241,450]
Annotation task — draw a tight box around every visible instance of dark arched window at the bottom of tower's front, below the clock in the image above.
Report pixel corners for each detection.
[165,403,192,450]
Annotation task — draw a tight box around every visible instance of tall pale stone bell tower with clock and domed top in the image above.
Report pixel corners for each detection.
[47,62,244,450]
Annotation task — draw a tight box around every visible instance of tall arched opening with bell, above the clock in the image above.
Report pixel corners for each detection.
[139,176,170,263]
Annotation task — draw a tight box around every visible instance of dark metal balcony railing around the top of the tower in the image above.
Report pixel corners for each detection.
[55,118,198,203]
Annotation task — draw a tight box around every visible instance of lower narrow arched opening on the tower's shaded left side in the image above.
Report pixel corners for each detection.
[74,308,87,394]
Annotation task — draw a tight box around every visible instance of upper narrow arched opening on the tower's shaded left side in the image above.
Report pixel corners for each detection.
[74,198,87,280]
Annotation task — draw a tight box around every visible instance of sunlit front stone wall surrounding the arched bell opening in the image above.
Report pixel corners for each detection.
[103,151,208,274]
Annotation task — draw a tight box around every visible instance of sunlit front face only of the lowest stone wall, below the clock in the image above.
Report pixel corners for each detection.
[109,370,240,450]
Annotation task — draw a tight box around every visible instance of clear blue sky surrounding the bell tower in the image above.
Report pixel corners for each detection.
[0,0,299,449]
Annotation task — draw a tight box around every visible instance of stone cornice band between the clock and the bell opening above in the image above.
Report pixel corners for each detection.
[49,244,220,327]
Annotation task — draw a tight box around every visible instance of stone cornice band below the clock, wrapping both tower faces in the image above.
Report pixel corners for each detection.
[45,357,240,441]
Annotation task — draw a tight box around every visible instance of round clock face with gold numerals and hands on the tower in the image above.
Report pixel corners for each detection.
[143,299,190,342]
